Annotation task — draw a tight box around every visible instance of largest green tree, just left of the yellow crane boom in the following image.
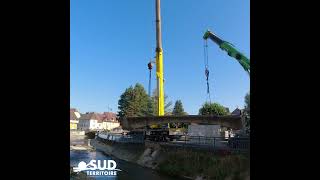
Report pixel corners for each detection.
[118,83,153,118]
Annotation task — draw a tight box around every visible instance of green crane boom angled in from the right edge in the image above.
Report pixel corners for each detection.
[203,30,250,76]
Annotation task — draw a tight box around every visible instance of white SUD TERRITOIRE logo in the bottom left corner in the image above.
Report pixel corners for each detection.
[73,160,121,176]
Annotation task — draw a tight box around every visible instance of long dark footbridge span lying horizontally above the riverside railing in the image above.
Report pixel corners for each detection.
[120,115,242,130]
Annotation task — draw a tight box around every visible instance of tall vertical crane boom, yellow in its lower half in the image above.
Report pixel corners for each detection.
[156,0,164,116]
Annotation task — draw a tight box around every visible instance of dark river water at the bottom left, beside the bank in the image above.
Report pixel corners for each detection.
[70,138,178,180]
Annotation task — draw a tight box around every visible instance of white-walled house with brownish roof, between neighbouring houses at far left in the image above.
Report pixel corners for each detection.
[78,112,102,131]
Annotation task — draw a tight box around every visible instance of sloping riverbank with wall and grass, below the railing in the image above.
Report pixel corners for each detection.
[90,138,250,180]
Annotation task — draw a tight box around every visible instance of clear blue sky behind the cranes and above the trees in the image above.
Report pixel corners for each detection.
[70,0,250,114]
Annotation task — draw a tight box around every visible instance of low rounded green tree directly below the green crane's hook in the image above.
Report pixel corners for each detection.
[199,102,229,116]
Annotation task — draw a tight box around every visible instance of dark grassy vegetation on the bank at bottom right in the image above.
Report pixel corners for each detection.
[158,150,250,180]
